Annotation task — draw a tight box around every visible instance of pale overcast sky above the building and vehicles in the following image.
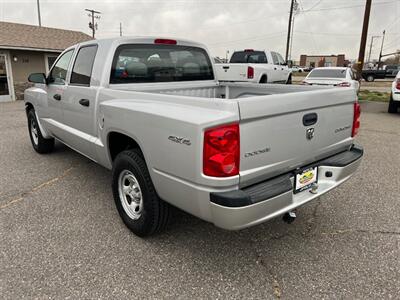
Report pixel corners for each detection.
[0,0,400,60]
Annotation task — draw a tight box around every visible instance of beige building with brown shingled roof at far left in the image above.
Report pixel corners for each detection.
[0,22,92,102]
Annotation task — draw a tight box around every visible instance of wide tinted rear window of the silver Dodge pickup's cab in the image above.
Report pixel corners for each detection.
[110,44,214,83]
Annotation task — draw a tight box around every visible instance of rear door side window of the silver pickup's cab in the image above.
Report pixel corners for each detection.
[71,45,97,85]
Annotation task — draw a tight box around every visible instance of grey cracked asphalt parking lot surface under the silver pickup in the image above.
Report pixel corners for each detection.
[0,101,400,299]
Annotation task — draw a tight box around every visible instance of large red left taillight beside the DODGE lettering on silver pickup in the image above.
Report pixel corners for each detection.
[203,124,240,177]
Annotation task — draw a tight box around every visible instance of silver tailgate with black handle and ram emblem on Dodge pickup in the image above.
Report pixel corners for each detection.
[237,88,356,187]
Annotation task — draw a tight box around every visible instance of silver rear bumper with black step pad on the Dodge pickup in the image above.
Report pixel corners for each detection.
[210,145,363,230]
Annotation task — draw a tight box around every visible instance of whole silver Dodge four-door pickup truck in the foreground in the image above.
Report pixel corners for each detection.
[25,38,363,236]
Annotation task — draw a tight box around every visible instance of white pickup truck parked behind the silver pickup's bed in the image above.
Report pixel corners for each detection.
[216,49,292,84]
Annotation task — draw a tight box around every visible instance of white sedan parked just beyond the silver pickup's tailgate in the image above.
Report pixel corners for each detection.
[302,67,360,91]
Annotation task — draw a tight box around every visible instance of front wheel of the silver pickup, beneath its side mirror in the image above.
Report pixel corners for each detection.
[27,109,54,154]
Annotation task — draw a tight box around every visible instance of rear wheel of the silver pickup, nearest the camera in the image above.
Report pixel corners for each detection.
[112,150,170,237]
